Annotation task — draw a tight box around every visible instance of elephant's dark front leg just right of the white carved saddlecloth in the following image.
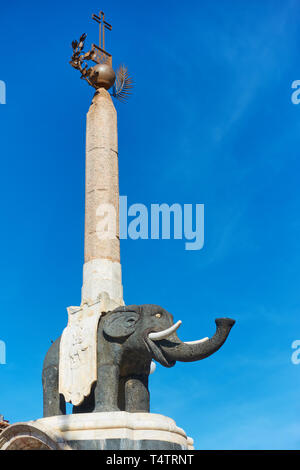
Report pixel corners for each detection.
[95,364,120,412]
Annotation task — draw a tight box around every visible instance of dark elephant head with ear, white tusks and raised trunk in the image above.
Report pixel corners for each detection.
[103,304,235,367]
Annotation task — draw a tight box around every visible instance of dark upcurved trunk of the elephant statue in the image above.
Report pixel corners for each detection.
[159,318,235,362]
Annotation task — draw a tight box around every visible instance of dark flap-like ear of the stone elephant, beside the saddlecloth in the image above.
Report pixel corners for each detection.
[103,311,139,338]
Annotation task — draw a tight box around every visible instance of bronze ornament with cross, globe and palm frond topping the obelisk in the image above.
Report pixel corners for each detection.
[70,11,133,102]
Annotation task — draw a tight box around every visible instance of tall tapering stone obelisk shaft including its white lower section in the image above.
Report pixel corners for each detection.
[82,88,124,307]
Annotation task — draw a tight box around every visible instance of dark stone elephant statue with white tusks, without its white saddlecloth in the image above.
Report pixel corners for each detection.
[43,304,235,417]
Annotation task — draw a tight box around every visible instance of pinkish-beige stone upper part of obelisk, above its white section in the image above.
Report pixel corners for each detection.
[84,89,120,263]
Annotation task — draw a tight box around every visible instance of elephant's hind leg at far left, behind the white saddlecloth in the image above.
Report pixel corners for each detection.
[43,365,66,418]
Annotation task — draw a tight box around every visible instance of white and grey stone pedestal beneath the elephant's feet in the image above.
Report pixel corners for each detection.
[0,411,194,450]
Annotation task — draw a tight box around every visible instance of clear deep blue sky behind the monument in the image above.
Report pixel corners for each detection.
[0,0,300,449]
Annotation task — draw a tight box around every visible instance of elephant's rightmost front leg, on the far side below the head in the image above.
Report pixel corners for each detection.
[125,374,150,413]
